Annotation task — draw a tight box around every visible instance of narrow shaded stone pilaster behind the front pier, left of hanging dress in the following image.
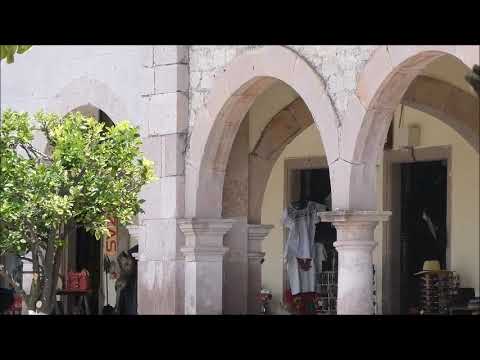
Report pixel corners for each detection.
[247,224,273,314]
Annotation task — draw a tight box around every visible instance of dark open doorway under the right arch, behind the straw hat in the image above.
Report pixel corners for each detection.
[400,160,447,314]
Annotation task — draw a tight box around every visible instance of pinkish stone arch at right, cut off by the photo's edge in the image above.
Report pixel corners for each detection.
[337,46,478,210]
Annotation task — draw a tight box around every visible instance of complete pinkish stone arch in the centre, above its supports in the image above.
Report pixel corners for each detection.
[185,46,339,218]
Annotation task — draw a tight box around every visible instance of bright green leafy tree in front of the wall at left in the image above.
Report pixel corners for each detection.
[0,110,154,313]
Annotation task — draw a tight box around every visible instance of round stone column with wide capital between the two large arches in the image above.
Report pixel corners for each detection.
[319,210,391,315]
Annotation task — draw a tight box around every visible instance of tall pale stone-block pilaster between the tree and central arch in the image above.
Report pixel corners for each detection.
[137,45,189,315]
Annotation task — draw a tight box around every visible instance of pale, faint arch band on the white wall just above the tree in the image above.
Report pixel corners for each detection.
[46,77,129,123]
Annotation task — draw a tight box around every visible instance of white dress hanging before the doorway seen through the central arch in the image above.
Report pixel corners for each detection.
[282,201,325,295]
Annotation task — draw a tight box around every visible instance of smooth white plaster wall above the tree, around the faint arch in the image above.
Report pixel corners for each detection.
[1,45,153,132]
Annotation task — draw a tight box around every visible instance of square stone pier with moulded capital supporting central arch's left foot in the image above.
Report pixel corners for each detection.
[178,219,233,315]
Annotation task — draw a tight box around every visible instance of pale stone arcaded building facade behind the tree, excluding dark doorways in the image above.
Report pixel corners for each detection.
[1,46,480,314]
